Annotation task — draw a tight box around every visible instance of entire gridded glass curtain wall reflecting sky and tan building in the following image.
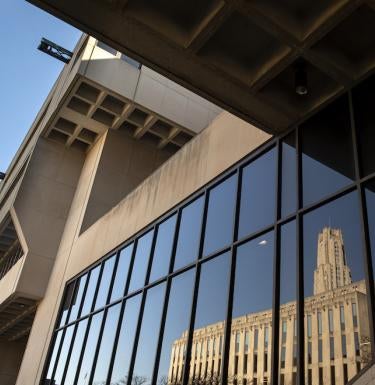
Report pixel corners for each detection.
[42,74,375,385]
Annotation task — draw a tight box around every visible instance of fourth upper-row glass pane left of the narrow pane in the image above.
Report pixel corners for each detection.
[150,215,177,282]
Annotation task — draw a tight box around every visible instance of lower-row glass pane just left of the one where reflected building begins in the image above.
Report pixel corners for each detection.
[132,283,166,385]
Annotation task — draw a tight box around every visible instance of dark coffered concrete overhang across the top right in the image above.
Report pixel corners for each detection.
[28,0,375,134]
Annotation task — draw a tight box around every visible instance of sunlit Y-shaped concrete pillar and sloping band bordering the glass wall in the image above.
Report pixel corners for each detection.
[17,113,269,385]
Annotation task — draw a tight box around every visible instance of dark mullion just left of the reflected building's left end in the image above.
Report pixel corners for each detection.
[151,209,181,384]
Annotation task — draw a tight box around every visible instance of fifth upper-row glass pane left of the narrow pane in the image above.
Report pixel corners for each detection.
[129,230,154,293]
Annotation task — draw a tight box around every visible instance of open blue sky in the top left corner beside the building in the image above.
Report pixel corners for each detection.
[0,0,81,171]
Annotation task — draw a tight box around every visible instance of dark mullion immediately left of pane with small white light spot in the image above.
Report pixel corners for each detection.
[220,167,243,385]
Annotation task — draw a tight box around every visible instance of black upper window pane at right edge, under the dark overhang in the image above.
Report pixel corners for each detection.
[353,76,375,176]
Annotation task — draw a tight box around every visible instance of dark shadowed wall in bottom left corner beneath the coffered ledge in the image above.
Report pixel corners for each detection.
[0,339,26,385]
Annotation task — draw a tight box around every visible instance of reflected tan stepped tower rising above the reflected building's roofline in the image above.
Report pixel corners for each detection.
[314,227,352,295]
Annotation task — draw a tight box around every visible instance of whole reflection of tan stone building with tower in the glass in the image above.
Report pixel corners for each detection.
[168,227,371,385]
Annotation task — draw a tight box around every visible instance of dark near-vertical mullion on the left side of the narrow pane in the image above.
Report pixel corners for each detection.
[270,136,283,385]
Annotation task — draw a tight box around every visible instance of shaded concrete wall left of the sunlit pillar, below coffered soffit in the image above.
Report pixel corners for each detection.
[14,138,84,299]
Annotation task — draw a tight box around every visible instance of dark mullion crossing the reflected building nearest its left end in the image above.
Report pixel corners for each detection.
[181,187,209,385]
